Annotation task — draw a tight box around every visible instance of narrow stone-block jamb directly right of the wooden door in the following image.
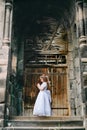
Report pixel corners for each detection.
[67,27,76,116]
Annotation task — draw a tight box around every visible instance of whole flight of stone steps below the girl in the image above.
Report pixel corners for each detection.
[3,116,85,130]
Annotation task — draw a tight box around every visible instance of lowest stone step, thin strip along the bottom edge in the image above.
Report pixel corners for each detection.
[3,126,85,130]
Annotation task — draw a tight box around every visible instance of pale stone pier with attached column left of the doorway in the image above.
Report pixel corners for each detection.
[0,0,12,126]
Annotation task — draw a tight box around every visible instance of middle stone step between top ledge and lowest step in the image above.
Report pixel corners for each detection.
[5,119,83,127]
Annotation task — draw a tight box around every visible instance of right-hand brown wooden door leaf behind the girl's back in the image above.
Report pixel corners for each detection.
[51,68,68,115]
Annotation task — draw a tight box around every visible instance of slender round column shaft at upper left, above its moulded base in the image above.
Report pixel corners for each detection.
[3,1,12,44]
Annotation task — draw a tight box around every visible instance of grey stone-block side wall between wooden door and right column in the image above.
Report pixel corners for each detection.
[68,24,83,116]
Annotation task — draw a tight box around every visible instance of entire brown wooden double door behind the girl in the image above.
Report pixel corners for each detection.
[24,67,69,116]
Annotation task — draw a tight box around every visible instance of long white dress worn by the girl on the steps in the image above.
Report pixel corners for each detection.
[33,82,51,116]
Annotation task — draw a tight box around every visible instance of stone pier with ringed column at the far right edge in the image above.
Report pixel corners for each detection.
[75,0,87,116]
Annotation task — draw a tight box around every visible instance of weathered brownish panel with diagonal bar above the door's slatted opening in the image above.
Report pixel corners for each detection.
[26,26,68,54]
